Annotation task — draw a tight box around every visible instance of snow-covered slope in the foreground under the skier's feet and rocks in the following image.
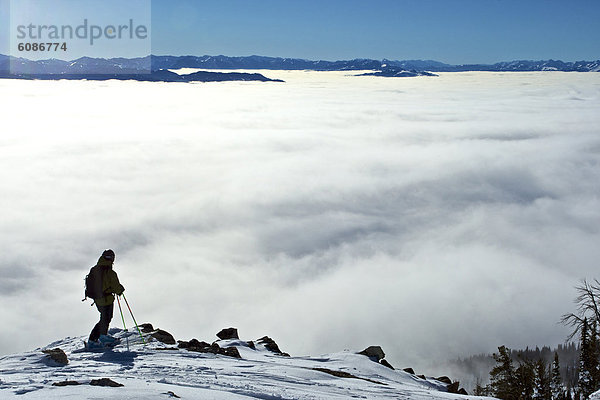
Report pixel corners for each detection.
[0,329,490,400]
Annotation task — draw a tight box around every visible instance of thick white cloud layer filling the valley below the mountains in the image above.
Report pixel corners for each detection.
[0,71,600,374]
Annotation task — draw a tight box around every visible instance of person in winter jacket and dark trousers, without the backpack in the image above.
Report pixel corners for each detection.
[89,249,125,342]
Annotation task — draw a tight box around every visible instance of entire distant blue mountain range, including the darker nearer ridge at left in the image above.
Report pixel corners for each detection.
[0,54,600,82]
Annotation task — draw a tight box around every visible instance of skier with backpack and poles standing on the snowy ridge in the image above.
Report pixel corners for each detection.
[86,249,125,347]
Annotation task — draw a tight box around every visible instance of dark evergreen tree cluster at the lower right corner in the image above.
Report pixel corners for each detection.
[450,279,600,400]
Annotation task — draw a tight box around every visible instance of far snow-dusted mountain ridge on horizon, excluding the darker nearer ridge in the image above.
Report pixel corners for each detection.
[0,54,600,74]
